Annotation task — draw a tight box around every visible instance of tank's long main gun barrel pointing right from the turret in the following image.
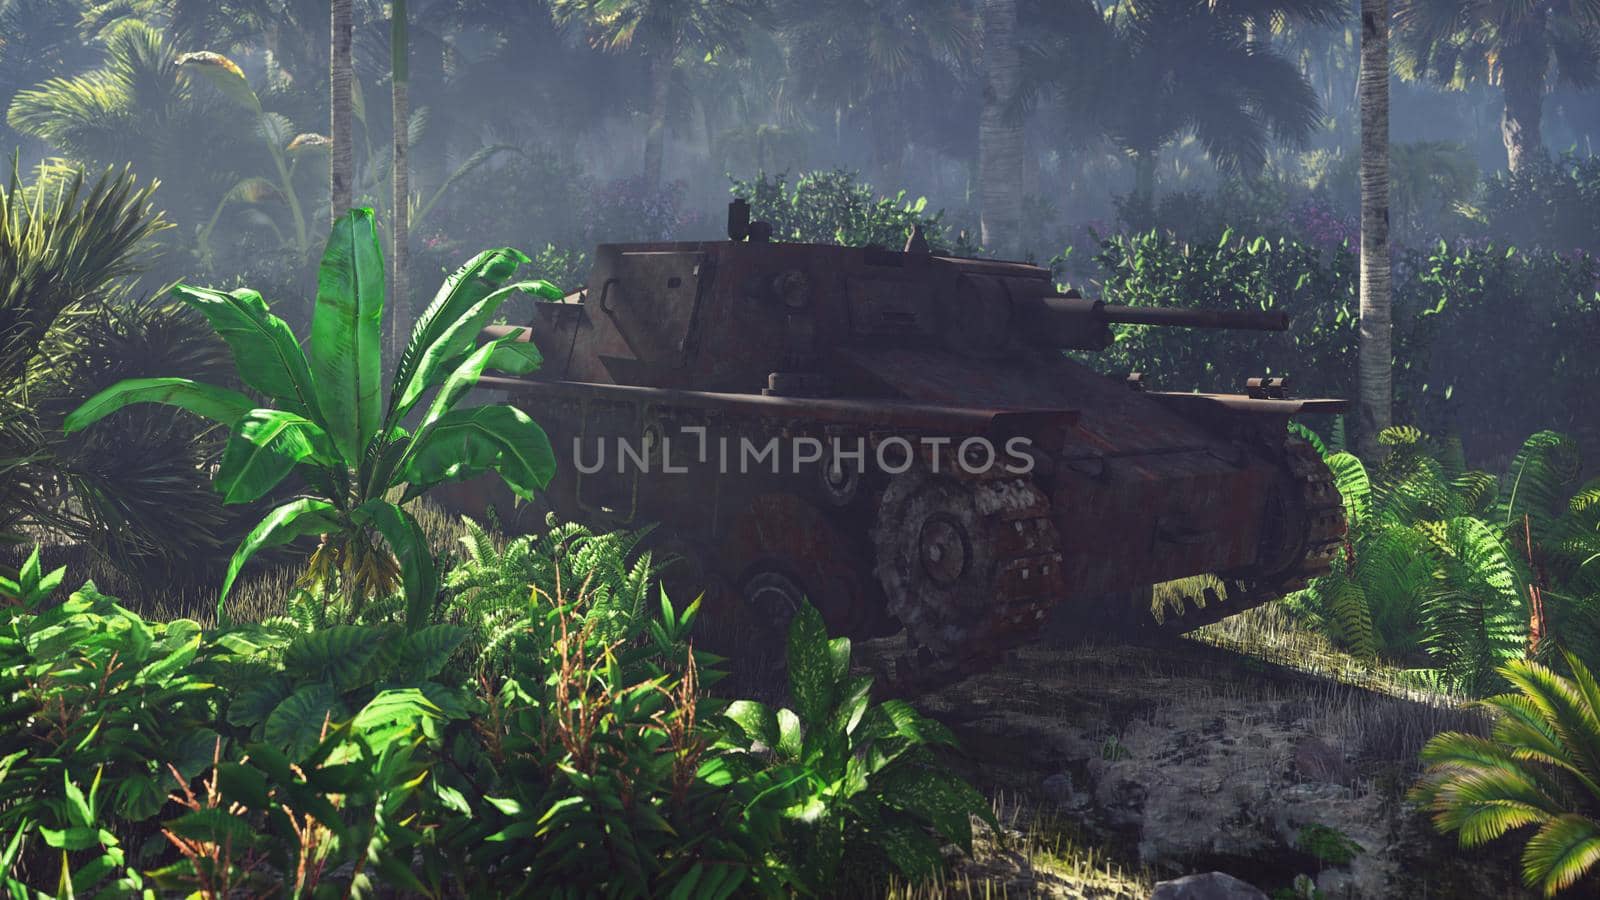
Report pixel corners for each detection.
[1021,291,1290,351]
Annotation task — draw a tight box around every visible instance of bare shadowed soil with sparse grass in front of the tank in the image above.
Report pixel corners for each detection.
[901,610,1531,900]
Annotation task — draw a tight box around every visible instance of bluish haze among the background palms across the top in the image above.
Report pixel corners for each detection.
[0,0,1600,273]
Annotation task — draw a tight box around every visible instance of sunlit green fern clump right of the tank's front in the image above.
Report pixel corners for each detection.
[1290,428,1600,692]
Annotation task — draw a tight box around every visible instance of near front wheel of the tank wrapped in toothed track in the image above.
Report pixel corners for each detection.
[872,469,1064,690]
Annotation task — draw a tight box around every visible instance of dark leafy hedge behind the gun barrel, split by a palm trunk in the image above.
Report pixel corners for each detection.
[1085,232,1600,458]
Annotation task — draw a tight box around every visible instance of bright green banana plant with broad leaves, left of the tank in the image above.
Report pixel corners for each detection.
[64,208,562,629]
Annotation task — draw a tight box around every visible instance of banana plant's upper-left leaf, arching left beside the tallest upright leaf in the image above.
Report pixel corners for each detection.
[173,285,323,423]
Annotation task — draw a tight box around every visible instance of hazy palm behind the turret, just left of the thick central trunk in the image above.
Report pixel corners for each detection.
[779,0,979,187]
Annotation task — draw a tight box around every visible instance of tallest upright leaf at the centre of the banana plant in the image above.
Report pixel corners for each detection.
[307,208,384,466]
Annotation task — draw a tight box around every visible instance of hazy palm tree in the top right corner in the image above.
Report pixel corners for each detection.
[1395,0,1600,171]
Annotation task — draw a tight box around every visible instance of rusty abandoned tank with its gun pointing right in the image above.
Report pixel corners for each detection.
[456,200,1346,684]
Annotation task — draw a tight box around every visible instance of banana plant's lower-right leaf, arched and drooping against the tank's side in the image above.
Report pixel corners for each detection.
[402,407,555,500]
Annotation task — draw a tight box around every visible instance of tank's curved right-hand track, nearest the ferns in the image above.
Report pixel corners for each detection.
[1157,436,1346,634]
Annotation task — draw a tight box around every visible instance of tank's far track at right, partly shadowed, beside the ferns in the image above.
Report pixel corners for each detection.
[1160,436,1346,634]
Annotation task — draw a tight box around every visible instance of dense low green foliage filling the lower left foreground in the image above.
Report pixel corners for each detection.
[0,525,994,897]
